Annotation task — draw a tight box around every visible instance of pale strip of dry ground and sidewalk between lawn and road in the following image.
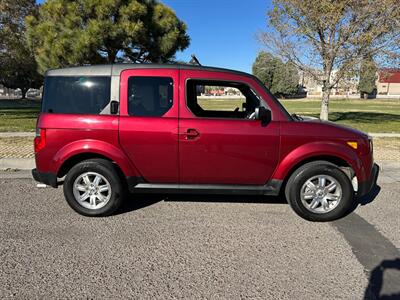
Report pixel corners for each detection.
[0,132,400,170]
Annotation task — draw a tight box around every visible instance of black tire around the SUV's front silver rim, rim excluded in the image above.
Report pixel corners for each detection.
[285,161,354,222]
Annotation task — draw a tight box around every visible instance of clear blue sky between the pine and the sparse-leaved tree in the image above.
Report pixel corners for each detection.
[38,0,271,72]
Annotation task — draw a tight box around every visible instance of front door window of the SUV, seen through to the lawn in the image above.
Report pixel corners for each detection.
[186,80,260,120]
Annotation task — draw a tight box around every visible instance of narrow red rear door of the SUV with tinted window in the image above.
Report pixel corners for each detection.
[119,69,179,183]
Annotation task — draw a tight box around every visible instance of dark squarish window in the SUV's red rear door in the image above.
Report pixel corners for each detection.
[128,77,173,117]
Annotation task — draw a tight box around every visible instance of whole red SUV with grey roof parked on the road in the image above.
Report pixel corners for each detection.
[32,64,379,221]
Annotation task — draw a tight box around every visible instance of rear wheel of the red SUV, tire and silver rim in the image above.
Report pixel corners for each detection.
[64,159,123,217]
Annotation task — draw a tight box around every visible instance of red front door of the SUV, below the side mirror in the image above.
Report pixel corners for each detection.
[179,70,280,185]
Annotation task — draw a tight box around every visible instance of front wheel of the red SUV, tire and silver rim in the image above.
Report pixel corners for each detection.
[285,161,354,222]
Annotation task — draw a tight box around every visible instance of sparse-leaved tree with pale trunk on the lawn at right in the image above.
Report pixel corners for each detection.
[260,0,400,120]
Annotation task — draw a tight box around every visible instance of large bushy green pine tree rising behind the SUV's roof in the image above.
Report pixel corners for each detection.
[27,0,190,72]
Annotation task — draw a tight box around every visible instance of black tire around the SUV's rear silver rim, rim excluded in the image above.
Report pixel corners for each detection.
[63,159,125,217]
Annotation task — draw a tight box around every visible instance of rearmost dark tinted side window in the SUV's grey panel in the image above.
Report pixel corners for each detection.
[42,76,111,114]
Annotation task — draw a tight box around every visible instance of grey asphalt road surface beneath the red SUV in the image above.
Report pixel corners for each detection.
[0,163,400,299]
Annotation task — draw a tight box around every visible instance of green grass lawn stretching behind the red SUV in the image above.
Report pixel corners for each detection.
[0,99,400,133]
